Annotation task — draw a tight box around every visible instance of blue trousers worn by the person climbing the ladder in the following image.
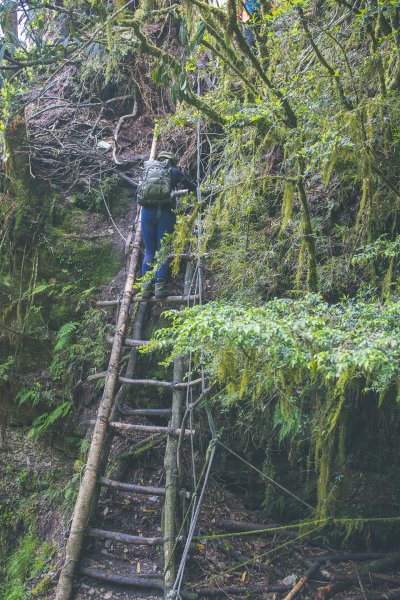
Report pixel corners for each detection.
[142,205,176,279]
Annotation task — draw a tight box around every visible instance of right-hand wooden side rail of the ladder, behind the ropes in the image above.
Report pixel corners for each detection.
[164,262,193,596]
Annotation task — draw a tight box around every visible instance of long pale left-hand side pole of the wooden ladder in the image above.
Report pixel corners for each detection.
[54,138,156,600]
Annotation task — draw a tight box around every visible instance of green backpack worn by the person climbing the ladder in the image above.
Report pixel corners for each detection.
[137,160,173,206]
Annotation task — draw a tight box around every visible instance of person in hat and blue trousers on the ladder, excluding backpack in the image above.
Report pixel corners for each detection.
[141,152,197,298]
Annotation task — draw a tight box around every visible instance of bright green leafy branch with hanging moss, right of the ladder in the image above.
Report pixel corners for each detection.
[149,295,400,511]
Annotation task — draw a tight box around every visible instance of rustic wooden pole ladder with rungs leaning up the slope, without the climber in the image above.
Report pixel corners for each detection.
[55,138,202,600]
